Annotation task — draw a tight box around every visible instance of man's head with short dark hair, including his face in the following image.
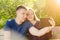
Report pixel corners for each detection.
[16,6,27,22]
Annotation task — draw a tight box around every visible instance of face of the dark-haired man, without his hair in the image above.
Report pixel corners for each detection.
[16,9,27,22]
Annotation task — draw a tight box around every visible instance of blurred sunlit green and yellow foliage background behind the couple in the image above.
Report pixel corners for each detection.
[0,0,60,29]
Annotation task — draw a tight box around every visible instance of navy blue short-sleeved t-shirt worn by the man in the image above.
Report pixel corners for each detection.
[4,19,32,35]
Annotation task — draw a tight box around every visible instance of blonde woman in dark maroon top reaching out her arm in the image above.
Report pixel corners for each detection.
[27,9,55,40]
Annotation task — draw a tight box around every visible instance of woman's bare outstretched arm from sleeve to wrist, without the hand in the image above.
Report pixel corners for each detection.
[29,27,51,37]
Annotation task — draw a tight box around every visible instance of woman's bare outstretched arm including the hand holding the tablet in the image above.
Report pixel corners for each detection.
[29,18,55,37]
